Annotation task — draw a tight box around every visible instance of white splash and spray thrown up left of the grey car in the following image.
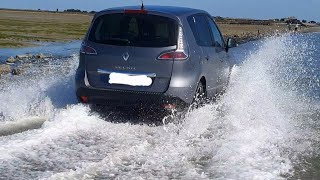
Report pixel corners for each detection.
[0,55,78,121]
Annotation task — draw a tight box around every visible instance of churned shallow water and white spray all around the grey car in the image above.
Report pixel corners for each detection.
[0,34,320,179]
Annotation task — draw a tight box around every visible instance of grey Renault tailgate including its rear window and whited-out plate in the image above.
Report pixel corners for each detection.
[85,13,178,92]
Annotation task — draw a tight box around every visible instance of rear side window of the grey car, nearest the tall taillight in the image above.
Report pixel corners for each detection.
[188,15,213,46]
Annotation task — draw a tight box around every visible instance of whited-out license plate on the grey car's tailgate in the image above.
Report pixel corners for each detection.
[109,73,152,86]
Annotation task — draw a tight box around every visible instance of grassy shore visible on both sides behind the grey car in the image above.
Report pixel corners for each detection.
[0,10,320,48]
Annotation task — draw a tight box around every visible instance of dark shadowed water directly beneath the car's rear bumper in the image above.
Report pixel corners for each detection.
[90,105,172,126]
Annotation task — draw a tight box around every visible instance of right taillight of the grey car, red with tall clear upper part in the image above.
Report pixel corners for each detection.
[158,27,189,60]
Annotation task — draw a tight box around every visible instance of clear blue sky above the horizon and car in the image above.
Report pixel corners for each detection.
[0,0,320,22]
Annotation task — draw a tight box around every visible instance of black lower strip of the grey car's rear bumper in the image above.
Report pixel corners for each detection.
[76,87,187,108]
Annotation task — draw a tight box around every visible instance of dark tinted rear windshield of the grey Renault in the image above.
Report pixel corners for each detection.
[89,13,178,47]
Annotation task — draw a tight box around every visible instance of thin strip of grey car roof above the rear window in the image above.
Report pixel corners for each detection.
[101,5,207,16]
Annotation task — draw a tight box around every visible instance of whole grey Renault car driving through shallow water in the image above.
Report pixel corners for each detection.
[75,6,232,108]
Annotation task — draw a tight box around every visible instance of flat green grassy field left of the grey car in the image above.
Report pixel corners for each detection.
[0,10,92,48]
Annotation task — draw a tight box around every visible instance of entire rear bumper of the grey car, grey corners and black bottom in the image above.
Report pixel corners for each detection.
[75,68,195,108]
